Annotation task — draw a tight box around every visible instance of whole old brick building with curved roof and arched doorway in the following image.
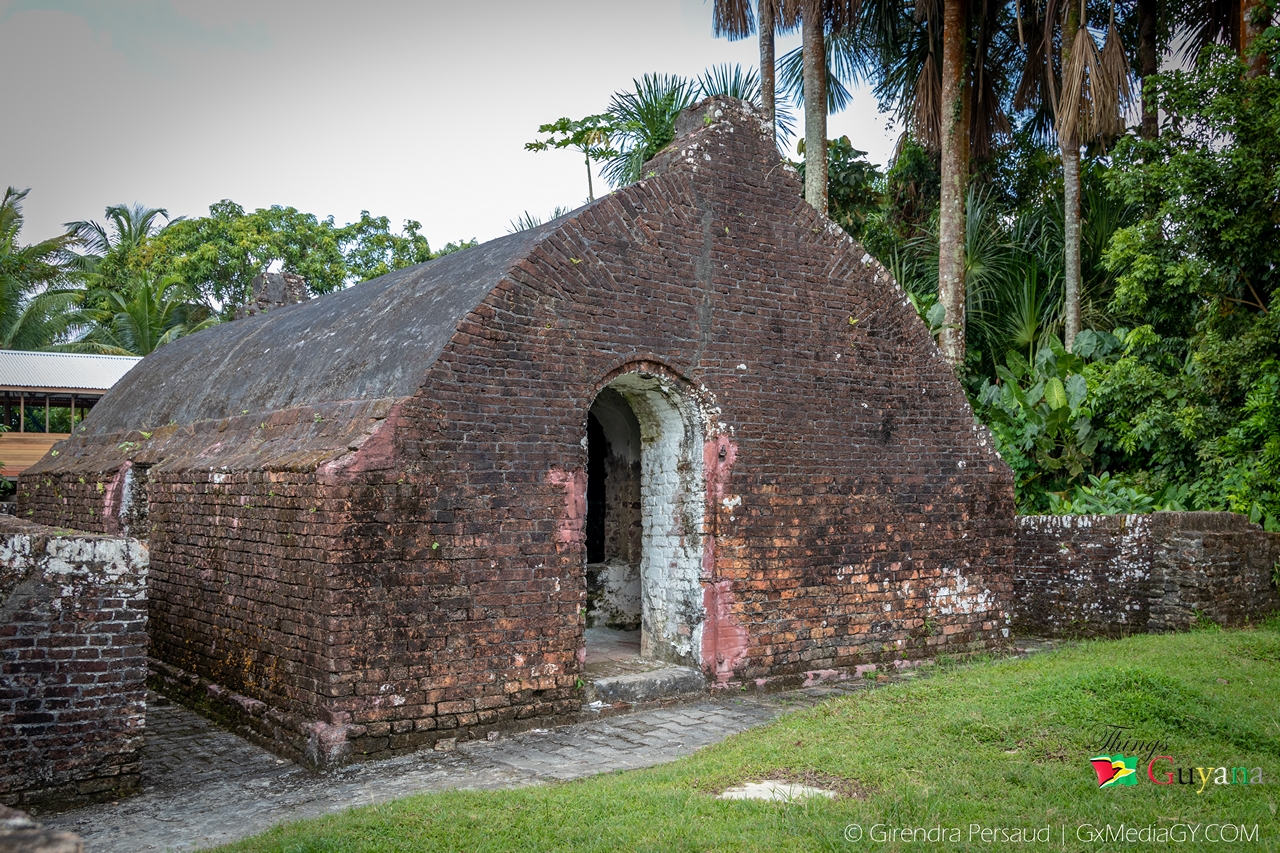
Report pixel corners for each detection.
[19,100,1014,763]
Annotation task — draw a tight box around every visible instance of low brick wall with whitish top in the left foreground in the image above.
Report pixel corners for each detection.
[0,516,147,811]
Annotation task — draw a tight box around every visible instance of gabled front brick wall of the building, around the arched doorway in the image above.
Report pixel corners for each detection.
[320,96,1014,748]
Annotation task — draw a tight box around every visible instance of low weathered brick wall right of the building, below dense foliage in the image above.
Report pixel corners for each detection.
[1011,512,1280,637]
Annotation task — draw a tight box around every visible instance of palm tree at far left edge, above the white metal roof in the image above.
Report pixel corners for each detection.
[0,187,83,350]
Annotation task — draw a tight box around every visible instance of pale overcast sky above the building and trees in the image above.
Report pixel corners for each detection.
[0,0,897,246]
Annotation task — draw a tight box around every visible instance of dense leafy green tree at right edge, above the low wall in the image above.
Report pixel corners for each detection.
[1070,51,1280,528]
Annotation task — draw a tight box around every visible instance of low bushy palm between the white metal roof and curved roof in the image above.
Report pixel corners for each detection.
[54,275,219,356]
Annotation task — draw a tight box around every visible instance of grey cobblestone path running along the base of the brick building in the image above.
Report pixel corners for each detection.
[52,690,808,853]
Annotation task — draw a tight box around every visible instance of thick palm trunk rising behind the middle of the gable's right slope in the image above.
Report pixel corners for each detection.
[936,0,969,365]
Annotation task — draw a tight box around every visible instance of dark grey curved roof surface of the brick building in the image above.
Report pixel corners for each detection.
[86,218,563,435]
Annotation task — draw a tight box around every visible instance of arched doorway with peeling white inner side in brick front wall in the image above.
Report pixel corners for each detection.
[585,371,707,667]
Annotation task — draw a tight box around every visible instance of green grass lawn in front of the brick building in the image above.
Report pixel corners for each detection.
[207,620,1280,853]
